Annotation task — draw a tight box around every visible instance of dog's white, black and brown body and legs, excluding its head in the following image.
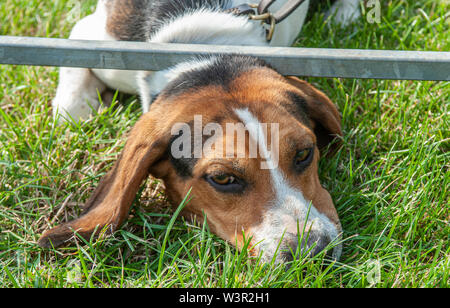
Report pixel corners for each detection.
[53,0,359,121]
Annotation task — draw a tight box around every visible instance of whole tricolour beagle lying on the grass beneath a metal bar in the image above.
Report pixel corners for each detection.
[38,0,362,262]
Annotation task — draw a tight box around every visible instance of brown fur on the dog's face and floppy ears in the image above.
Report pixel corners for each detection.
[39,68,342,247]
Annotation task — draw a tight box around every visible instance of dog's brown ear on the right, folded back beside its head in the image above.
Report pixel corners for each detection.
[286,76,342,153]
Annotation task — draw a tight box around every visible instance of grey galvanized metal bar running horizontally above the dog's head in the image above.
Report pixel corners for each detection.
[0,36,450,81]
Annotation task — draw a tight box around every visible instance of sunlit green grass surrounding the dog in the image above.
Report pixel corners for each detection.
[0,0,450,287]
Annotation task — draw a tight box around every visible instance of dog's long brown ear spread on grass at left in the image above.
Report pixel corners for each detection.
[38,112,170,248]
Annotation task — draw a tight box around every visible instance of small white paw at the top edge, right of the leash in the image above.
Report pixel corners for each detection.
[325,0,361,27]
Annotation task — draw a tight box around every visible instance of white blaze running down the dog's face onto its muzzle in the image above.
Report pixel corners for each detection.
[234,109,341,259]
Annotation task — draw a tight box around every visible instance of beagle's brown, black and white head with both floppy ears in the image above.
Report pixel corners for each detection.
[39,56,342,261]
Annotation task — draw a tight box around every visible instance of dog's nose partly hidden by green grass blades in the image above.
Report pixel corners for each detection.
[283,230,331,261]
